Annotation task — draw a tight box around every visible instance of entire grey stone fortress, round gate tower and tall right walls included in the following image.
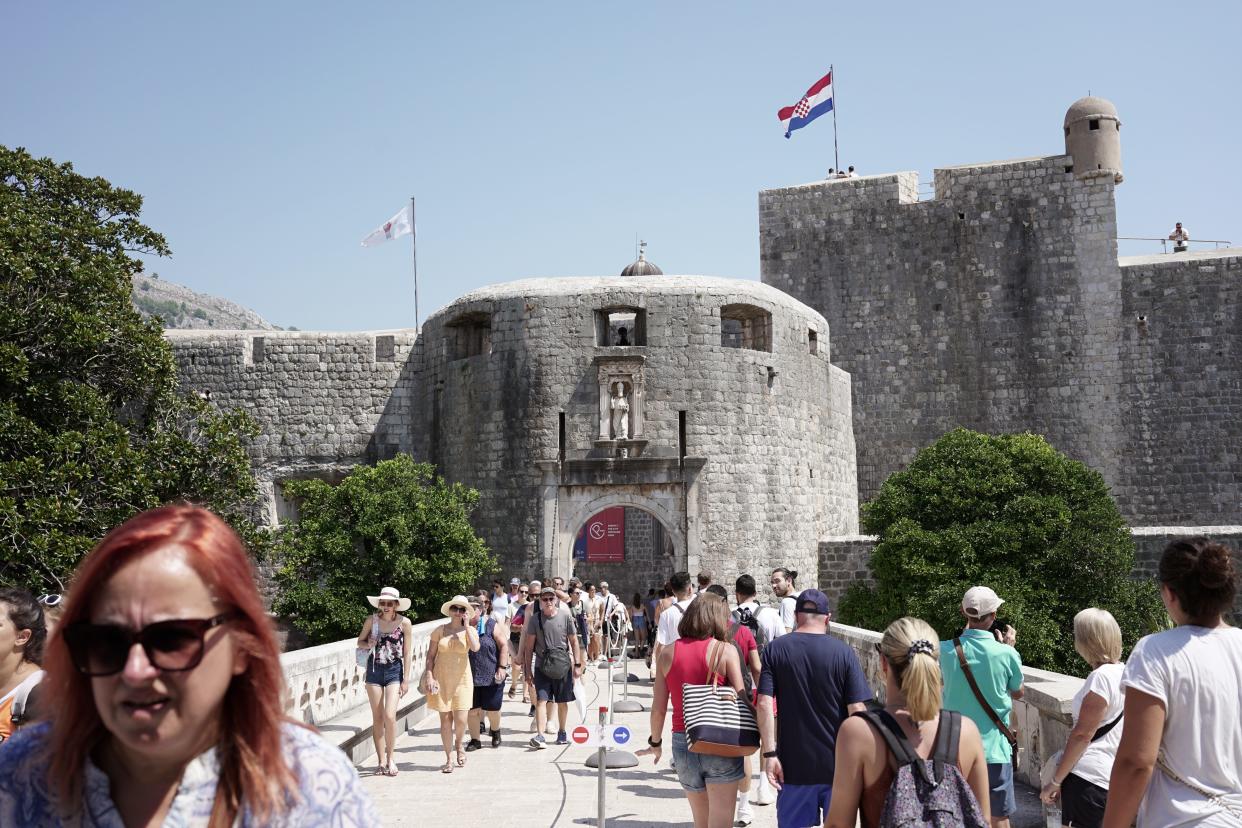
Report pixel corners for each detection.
[168,98,1242,613]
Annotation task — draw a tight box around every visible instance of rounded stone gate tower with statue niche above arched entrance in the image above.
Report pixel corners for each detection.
[414,276,858,597]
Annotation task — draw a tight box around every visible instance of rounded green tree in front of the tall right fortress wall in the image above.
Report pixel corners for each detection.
[841,428,1166,675]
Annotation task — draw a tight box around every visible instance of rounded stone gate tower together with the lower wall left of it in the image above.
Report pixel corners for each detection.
[169,276,858,603]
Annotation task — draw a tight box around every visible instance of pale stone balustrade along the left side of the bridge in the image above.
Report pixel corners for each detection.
[281,621,443,725]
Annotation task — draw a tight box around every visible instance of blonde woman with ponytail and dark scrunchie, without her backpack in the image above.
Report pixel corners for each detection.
[823,618,991,828]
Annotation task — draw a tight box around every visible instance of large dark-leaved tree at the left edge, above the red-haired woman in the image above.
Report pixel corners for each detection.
[0,146,262,591]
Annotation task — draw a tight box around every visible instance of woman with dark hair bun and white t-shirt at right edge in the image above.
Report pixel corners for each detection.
[1104,538,1242,828]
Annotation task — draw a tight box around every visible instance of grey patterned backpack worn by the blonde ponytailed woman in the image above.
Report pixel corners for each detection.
[854,710,989,828]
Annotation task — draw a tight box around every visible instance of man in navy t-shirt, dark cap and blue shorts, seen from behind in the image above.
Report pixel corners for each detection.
[759,590,873,828]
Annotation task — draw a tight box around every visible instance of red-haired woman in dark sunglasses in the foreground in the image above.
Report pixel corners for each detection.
[0,505,378,827]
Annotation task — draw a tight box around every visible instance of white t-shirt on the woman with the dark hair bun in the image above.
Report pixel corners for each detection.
[1122,624,1242,828]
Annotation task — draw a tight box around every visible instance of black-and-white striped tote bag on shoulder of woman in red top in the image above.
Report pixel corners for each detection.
[682,641,759,756]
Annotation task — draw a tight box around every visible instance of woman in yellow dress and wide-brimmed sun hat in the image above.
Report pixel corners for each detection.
[422,595,478,773]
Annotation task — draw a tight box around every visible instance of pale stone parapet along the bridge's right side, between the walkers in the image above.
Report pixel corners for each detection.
[831,622,1083,790]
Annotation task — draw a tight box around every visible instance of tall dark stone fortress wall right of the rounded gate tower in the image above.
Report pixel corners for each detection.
[759,99,1242,526]
